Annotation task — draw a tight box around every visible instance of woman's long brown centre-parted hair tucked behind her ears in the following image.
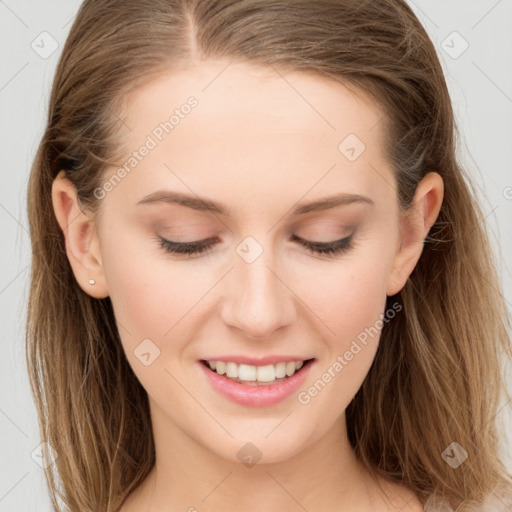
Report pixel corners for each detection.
[27,0,512,512]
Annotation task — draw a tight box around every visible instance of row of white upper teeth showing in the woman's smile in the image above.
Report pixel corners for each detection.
[208,361,304,382]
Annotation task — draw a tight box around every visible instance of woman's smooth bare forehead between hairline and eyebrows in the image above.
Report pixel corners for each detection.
[103,60,394,216]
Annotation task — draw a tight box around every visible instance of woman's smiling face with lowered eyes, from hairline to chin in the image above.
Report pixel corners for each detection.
[54,61,442,462]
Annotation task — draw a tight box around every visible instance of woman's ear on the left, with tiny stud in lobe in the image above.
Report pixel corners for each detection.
[52,171,108,299]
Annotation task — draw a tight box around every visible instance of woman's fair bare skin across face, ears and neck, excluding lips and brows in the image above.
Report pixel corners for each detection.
[52,61,443,512]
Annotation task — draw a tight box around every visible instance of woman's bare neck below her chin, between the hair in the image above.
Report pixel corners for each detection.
[122,404,414,512]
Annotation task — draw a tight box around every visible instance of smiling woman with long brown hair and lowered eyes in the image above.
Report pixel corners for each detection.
[27,0,512,512]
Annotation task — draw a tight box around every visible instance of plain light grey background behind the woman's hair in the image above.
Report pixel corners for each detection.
[0,0,512,512]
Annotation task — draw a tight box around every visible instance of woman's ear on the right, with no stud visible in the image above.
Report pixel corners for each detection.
[386,172,444,296]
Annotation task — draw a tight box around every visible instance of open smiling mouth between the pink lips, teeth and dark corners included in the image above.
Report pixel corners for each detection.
[200,358,315,387]
